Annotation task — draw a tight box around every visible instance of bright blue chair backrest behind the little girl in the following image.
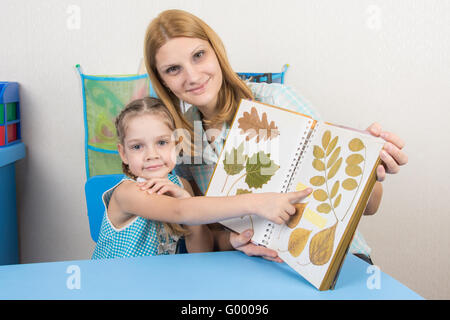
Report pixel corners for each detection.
[84,174,123,242]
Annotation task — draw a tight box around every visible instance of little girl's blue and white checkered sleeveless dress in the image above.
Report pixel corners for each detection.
[92,174,183,259]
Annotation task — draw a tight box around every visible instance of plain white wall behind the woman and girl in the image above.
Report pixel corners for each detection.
[0,0,450,299]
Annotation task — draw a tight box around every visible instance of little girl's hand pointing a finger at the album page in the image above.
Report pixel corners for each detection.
[252,188,312,224]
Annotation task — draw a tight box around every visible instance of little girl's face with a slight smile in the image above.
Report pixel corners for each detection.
[118,114,176,180]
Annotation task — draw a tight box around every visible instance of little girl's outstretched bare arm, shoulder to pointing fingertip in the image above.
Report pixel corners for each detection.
[111,181,312,225]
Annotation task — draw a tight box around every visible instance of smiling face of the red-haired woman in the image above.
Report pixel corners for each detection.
[155,37,222,115]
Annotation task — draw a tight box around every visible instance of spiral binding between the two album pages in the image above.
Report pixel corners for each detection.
[261,121,318,246]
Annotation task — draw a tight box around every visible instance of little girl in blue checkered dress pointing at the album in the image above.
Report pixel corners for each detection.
[92,97,312,259]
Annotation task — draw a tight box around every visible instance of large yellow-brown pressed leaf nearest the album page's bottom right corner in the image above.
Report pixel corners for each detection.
[309,223,337,266]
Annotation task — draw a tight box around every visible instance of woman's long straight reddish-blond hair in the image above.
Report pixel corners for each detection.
[144,10,253,141]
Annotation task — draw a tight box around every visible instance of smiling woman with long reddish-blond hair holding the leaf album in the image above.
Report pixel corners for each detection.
[144,10,407,262]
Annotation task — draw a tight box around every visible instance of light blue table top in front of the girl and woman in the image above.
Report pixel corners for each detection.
[0,251,422,300]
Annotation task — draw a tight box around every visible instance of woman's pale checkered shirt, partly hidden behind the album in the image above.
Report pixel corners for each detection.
[174,82,371,256]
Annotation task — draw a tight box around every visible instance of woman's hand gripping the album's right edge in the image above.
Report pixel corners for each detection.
[367,122,408,182]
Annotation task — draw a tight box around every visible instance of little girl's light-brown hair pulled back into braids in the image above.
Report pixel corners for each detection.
[115,97,188,239]
